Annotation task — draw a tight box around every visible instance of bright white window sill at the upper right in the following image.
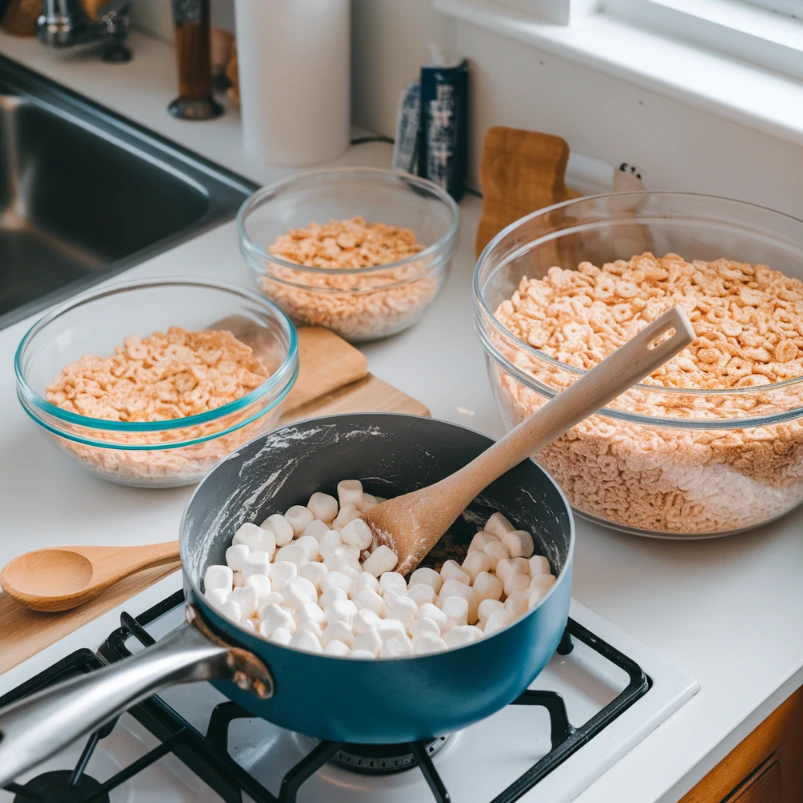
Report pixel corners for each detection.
[434,0,803,145]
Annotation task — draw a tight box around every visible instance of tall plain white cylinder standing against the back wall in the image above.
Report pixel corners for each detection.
[235,0,351,165]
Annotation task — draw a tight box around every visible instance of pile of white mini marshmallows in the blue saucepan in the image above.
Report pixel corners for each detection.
[204,480,555,659]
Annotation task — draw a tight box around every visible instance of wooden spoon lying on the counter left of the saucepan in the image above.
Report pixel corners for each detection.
[0,541,179,613]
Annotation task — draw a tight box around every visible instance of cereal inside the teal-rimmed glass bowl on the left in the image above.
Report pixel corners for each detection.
[46,326,269,484]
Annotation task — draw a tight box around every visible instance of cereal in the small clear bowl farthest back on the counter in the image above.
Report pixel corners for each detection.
[259,217,439,341]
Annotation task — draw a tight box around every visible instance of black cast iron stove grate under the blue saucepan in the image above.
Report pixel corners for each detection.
[0,591,651,803]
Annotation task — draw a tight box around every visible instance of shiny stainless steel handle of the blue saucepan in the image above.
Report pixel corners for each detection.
[0,608,273,787]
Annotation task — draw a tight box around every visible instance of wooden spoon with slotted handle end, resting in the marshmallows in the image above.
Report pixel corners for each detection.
[361,307,695,574]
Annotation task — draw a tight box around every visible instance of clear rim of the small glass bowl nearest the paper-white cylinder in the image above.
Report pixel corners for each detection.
[236,167,460,276]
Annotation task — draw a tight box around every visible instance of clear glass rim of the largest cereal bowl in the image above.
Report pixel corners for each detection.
[473,190,803,428]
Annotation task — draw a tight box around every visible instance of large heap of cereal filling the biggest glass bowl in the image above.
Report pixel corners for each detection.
[491,253,803,535]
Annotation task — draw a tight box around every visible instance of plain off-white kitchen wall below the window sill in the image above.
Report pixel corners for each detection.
[133,0,803,217]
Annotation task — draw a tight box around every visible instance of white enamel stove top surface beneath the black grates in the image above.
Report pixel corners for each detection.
[0,575,699,803]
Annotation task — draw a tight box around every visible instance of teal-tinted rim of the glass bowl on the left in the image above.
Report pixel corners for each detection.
[14,276,298,436]
